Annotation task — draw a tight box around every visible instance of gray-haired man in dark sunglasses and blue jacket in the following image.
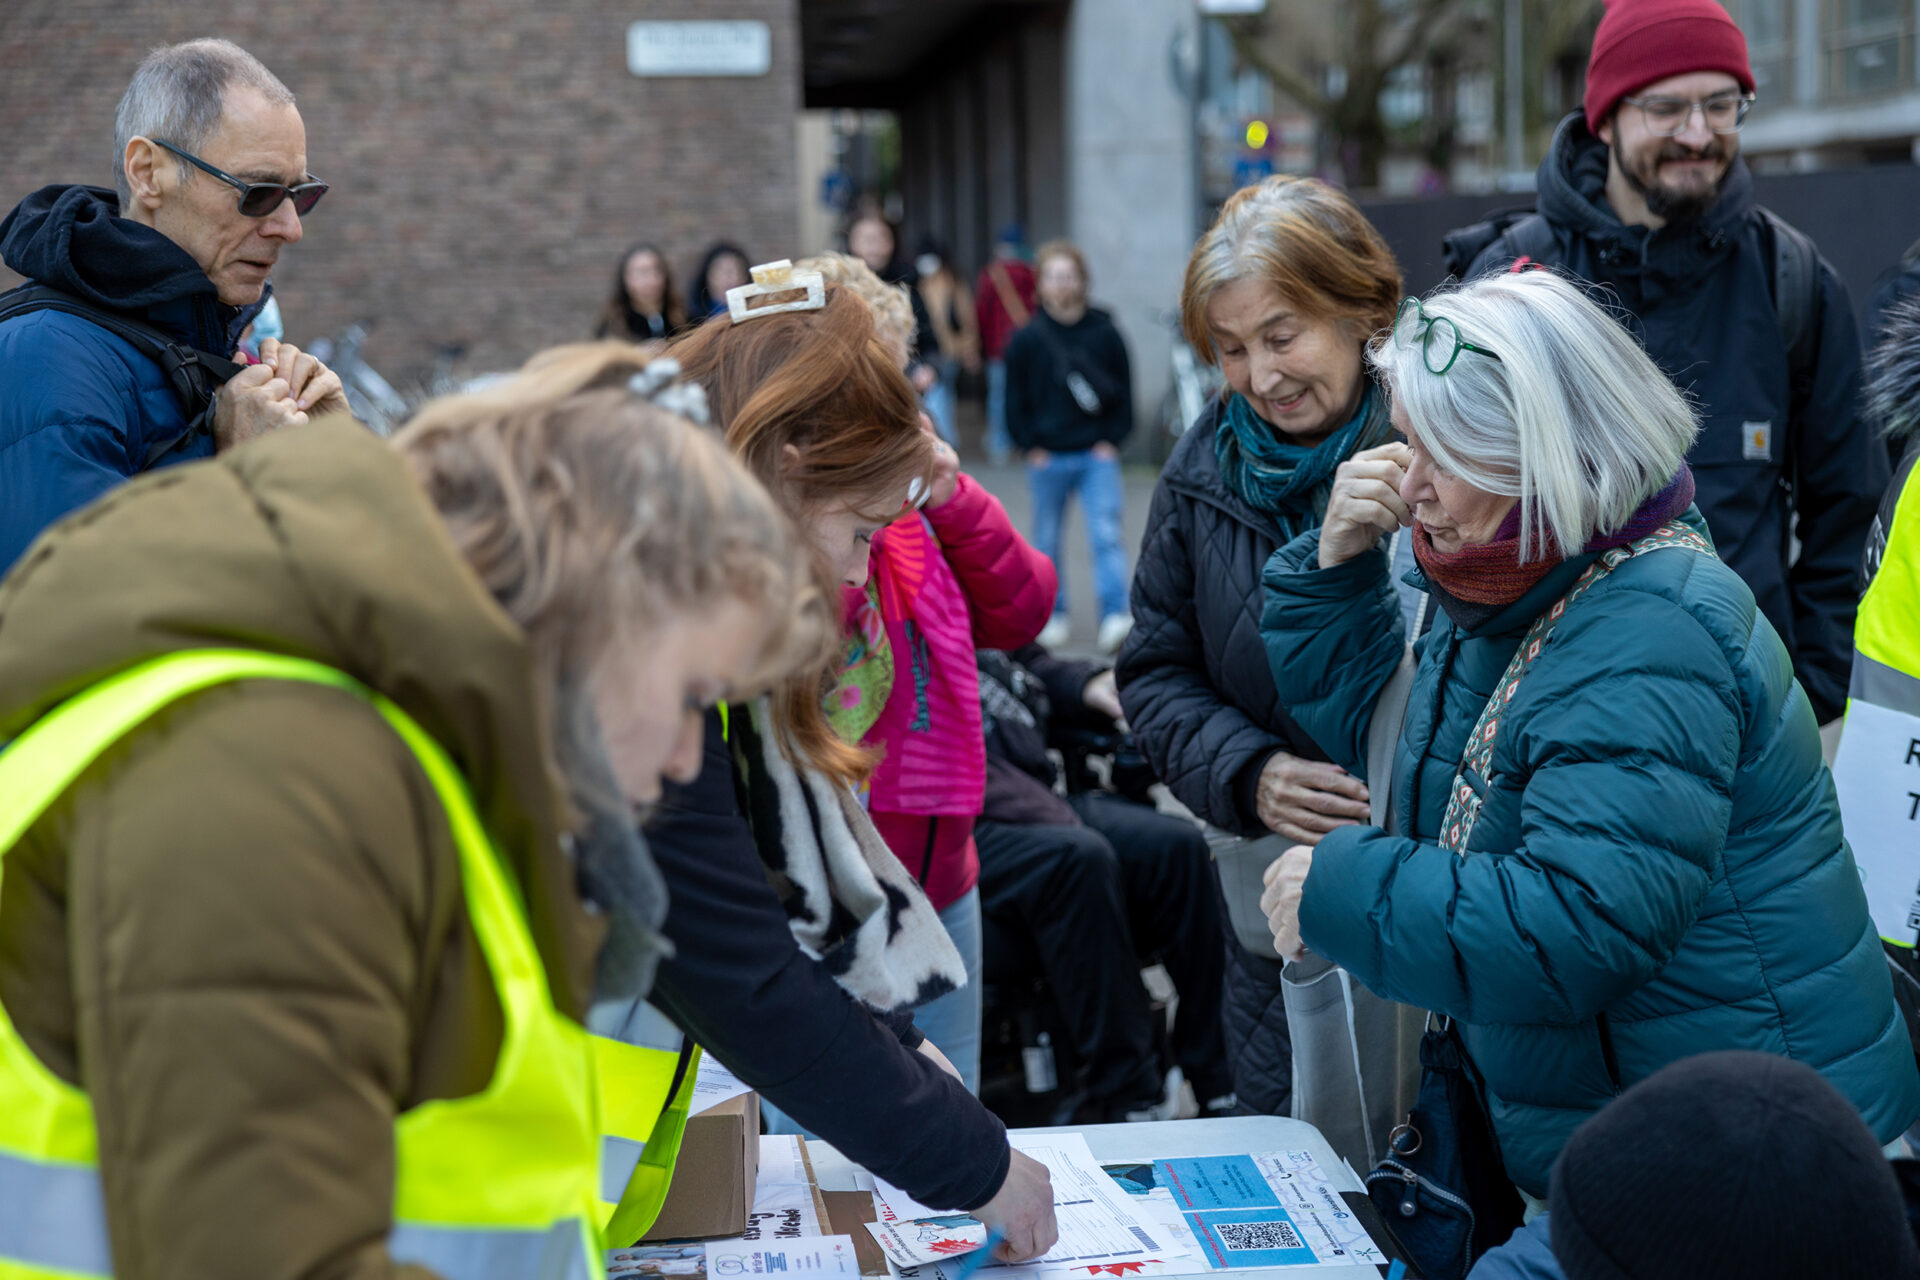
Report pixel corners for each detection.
[0,40,346,572]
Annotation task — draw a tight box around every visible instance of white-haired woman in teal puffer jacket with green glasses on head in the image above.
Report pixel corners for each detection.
[1261,271,1920,1220]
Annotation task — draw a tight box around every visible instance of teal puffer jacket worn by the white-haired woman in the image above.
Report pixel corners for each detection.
[1261,509,1920,1196]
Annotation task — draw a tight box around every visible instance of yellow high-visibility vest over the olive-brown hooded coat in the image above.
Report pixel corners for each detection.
[0,649,601,1280]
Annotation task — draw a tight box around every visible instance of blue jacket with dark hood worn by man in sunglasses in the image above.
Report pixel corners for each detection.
[0,186,265,574]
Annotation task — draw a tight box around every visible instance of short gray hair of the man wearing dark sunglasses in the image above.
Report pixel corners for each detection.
[113,36,294,213]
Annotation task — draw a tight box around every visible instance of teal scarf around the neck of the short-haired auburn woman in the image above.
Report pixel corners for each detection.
[1213,382,1394,541]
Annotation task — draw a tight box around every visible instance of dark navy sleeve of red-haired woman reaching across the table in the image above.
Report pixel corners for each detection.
[647,714,1010,1209]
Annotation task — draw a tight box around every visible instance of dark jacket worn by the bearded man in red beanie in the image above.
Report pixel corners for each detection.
[1467,111,1887,723]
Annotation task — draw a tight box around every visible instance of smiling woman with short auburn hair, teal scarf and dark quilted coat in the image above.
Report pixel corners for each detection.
[1116,177,1400,1115]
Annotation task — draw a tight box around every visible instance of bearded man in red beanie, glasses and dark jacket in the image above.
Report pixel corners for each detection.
[1446,0,1887,723]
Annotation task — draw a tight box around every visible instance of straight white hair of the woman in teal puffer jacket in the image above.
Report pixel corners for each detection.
[1367,271,1699,560]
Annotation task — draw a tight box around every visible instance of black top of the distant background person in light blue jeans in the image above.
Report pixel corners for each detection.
[1006,307,1133,453]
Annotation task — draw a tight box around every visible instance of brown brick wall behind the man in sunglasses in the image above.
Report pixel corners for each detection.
[0,0,801,382]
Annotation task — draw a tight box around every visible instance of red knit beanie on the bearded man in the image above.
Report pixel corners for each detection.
[1586,0,1753,129]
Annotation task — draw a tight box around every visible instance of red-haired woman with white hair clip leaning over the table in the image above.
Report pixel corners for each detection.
[647,282,1056,1259]
